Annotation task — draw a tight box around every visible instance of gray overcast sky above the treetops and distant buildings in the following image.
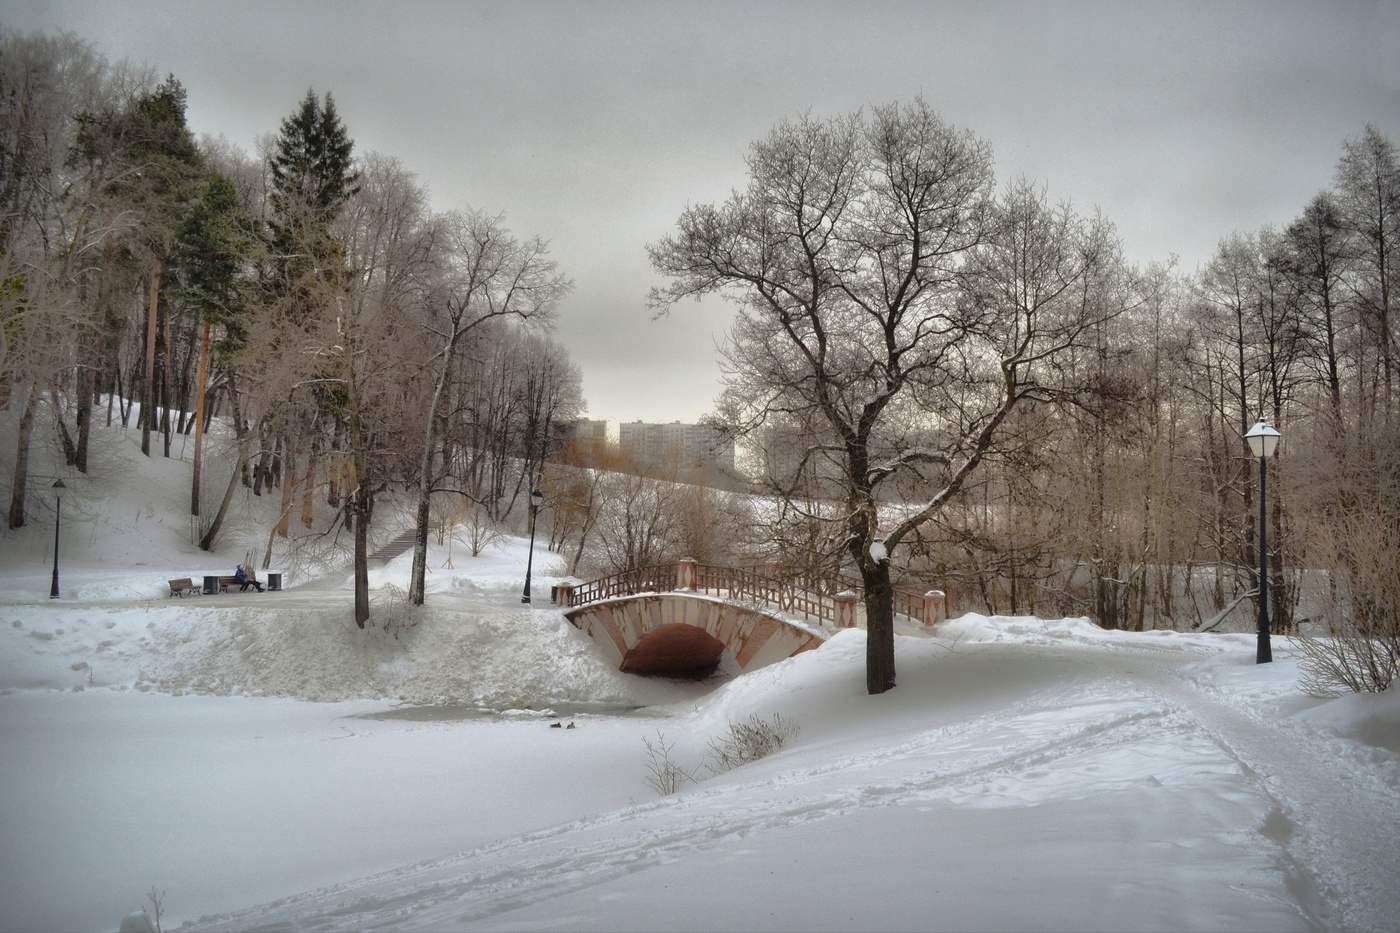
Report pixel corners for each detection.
[0,0,1400,420]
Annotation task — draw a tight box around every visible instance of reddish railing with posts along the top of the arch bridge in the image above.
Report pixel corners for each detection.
[559,560,944,628]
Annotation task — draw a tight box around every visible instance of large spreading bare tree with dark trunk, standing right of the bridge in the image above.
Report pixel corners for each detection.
[650,99,1116,693]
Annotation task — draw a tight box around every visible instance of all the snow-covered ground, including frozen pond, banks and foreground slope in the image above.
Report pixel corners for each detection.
[0,423,1400,930]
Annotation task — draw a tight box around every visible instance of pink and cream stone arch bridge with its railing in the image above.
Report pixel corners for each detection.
[556,560,944,675]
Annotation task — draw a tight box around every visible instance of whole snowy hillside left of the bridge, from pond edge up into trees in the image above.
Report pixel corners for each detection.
[0,412,666,709]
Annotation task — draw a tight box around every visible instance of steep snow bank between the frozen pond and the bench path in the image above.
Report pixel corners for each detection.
[0,597,666,709]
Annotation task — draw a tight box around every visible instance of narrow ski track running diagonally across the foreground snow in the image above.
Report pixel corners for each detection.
[189,686,1154,930]
